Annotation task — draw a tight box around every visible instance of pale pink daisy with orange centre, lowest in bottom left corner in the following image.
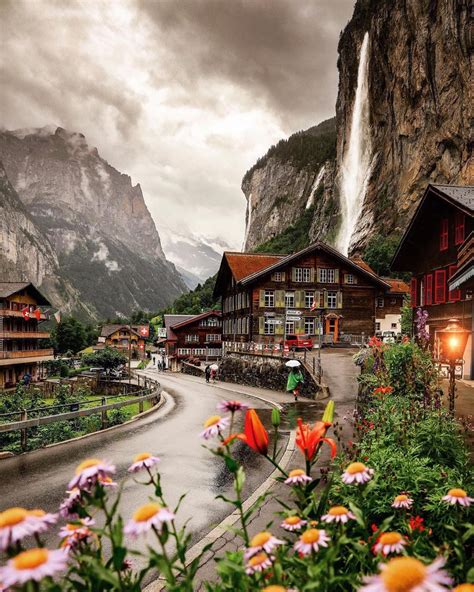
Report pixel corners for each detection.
[0,548,67,588]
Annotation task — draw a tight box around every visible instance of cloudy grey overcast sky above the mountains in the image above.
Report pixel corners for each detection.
[0,0,354,248]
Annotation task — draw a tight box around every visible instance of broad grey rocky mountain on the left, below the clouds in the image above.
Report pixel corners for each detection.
[0,127,186,318]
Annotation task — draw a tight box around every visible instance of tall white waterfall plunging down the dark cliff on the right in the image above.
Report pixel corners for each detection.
[336,33,371,255]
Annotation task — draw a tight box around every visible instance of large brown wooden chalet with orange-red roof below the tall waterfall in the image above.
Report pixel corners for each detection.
[214,242,390,345]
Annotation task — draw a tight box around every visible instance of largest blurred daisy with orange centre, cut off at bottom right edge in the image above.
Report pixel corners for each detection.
[359,557,452,592]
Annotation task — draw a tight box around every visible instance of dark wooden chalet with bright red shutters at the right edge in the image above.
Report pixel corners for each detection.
[392,185,474,379]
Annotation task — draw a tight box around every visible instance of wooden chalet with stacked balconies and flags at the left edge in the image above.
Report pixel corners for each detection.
[0,282,54,388]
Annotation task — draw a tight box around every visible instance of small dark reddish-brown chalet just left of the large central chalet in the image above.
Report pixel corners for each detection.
[164,310,222,370]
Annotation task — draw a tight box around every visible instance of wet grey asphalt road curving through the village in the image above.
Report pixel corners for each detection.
[0,372,272,546]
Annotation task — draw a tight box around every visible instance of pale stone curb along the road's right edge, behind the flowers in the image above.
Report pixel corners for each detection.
[143,428,296,592]
